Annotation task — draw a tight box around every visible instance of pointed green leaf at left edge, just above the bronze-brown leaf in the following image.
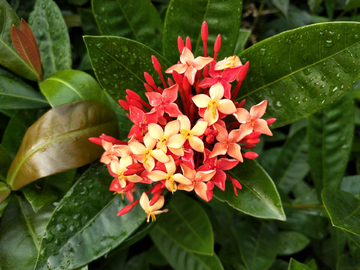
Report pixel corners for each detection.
[0,76,49,109]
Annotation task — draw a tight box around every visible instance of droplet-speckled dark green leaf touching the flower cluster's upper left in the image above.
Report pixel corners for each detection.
[84,36,171,102]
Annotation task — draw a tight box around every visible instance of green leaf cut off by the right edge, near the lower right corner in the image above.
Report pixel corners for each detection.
[321,188,360,235]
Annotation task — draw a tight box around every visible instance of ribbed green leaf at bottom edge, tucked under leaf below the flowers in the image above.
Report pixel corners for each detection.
[150,226,224,270]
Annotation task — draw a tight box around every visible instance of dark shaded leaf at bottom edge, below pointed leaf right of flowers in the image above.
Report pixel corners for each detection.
[232,218,277,270]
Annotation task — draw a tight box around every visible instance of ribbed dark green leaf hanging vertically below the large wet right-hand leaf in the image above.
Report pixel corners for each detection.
[308,93,354,198]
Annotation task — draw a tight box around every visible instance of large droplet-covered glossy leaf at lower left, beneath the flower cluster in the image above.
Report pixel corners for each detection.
[35,164,147,270]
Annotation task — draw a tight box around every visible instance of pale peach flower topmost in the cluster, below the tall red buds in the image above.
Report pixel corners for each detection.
[165,47,213,85]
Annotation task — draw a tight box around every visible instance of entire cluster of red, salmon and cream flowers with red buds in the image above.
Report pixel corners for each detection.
[90,22,275,221]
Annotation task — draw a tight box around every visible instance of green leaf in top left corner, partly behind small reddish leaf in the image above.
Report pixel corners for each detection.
[0,0,37,81]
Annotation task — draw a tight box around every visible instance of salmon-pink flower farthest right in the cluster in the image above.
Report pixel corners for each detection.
[234,100,272,136]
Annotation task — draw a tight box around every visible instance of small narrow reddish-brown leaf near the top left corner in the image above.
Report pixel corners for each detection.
[11,26,41,80]
